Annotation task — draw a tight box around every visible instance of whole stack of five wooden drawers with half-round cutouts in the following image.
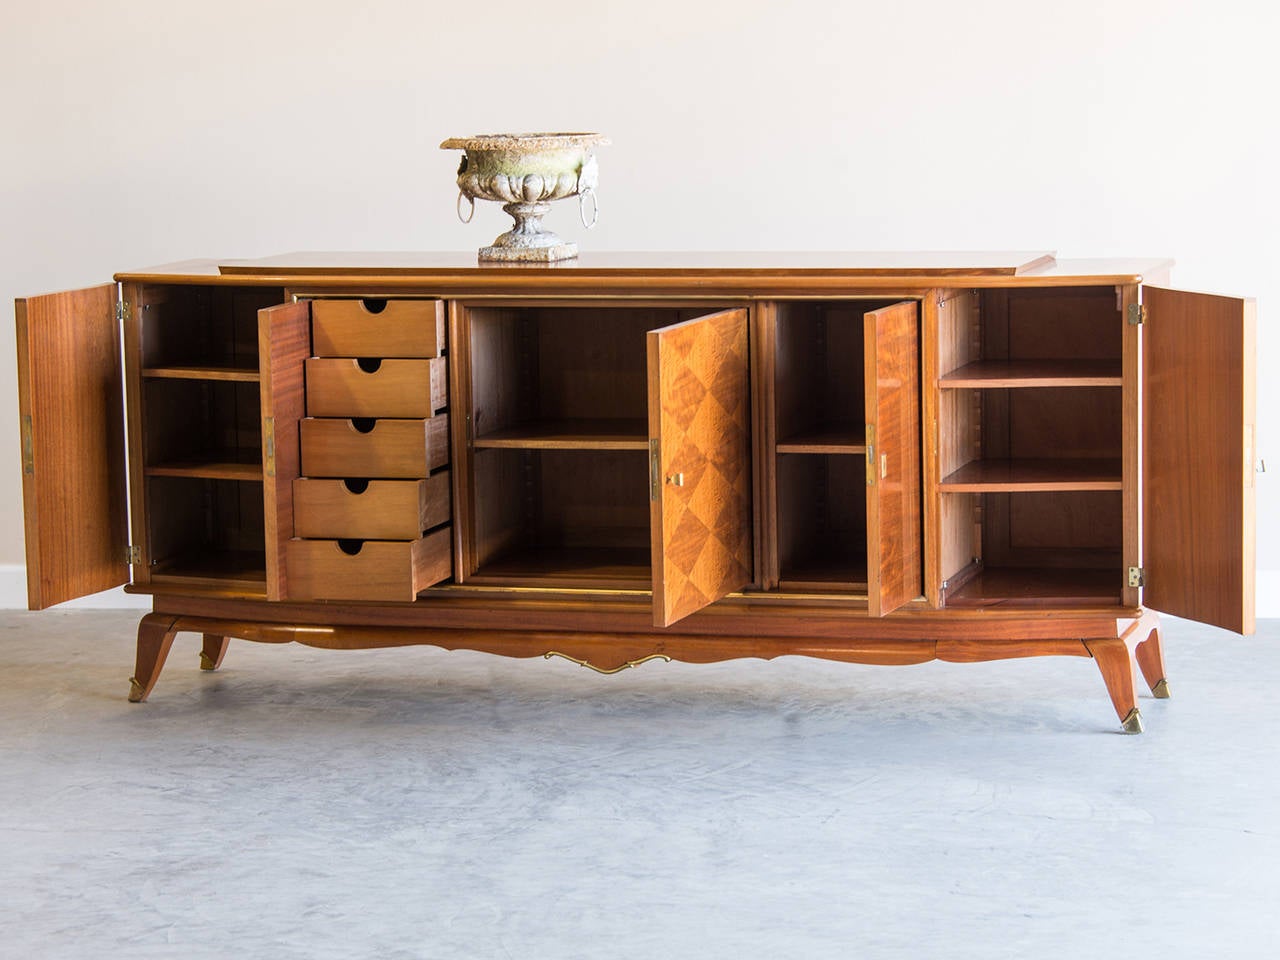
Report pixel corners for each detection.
[287,300,453,600]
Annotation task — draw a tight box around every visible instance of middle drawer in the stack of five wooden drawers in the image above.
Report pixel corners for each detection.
[298,413,449,480]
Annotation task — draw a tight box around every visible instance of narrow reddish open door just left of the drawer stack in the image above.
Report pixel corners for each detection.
[257,301,311,600]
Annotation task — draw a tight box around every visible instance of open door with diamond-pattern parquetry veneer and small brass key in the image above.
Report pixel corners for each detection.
[648,310,751,627]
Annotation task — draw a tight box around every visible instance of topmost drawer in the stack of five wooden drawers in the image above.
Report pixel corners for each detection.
[311,300,447,357]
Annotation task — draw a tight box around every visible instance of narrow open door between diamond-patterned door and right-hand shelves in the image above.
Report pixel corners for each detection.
[863,301,923,617]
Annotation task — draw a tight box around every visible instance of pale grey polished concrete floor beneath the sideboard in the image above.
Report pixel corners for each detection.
[0,611,1280,960]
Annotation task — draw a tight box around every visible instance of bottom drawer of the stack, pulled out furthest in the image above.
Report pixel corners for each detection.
[285,527,453,602]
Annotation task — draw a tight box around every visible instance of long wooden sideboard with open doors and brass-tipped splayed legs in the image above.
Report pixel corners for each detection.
[17,253,1254,732]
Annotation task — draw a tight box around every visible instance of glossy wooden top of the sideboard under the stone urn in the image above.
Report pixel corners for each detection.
[116,251,1172,292]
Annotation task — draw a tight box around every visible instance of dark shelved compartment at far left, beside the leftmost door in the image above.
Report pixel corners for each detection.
[125,284,284,584]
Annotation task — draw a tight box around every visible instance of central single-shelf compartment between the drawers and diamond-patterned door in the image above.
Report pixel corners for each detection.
[463,305,708,589]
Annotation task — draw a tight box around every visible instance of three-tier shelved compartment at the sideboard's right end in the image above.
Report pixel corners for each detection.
[938,287,1124,605]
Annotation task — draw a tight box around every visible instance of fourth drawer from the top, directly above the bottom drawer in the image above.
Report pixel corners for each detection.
[293,470,449,540]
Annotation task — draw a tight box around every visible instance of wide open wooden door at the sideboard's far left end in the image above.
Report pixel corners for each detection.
[15,283,129,611]
